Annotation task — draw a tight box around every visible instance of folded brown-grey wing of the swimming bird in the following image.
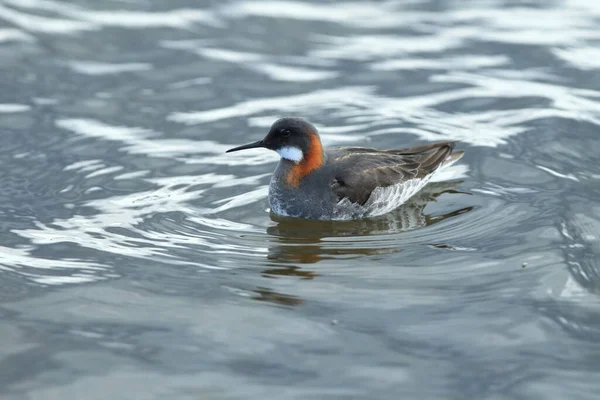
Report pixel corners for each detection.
[332,142,456,205]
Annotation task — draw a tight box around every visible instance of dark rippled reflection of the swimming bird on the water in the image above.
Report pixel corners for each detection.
[254,180,473,306]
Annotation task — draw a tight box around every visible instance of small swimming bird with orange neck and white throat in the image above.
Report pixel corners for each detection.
[226,117,464,220]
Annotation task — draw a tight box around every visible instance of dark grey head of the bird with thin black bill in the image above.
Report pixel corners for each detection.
[227,117,323,164]
